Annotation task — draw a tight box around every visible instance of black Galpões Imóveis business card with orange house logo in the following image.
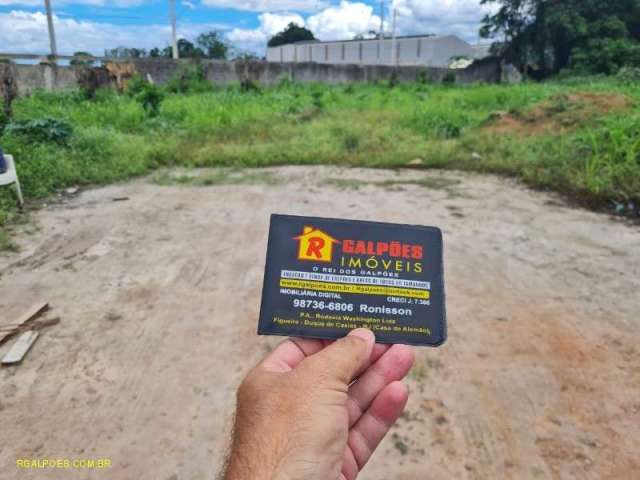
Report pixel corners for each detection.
[258,215,447,347]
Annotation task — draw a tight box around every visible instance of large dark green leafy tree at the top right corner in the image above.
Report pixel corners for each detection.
[480,0,640,75]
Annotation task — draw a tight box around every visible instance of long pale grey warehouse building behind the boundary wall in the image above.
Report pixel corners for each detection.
[267,35,476,67]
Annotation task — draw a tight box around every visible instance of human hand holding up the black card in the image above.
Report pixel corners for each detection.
[224,329,414,480]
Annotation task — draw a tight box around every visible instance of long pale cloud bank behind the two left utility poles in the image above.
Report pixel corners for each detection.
[0,11,224,55]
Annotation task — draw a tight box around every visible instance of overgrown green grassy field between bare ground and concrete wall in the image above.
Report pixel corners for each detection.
[0,77,640,249]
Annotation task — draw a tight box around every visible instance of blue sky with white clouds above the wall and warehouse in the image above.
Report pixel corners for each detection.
[0,0,491,55]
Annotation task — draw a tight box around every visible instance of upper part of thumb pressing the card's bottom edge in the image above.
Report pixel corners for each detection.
[309,328,376,384]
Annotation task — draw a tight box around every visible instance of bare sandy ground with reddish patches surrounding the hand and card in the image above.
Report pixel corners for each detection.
[0,167,640,480]
